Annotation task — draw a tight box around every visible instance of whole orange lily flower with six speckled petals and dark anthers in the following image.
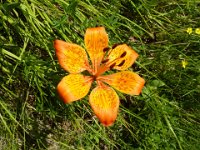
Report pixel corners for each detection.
[54,27,145,126]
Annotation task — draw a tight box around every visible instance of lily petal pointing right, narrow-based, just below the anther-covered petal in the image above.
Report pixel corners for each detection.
[97,71,145,95]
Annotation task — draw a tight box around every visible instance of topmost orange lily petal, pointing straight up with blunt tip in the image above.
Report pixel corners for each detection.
[84,27,108,72]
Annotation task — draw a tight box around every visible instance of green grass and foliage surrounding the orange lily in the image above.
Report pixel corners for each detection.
[0,0,200,150]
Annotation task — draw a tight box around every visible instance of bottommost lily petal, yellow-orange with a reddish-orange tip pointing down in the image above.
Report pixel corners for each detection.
[89,83,119,126]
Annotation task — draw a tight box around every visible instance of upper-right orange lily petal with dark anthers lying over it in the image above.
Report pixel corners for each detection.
[107,44,139,70]
